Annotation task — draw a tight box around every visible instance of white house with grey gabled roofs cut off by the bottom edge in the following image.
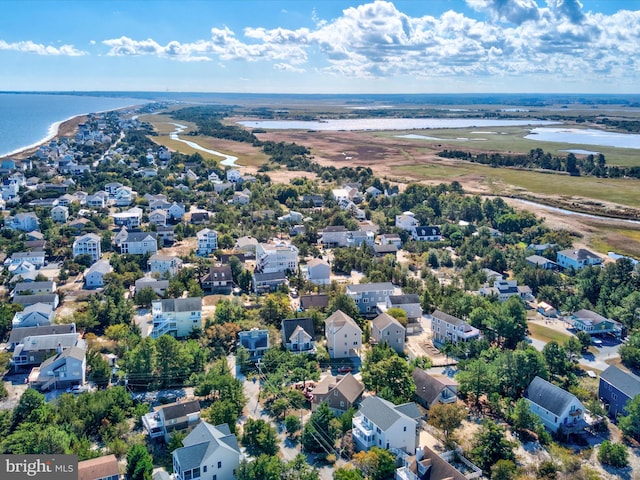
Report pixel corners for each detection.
[172,422,242,480]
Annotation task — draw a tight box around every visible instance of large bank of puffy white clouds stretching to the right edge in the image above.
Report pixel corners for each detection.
[97,0,640,80]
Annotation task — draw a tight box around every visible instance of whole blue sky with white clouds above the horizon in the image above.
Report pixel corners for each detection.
[0,0,640,93]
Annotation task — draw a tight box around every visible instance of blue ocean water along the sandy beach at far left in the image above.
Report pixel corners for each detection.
[0,93,149,156]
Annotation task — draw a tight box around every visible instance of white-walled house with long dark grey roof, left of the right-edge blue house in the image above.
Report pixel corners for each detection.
[523,377,585,432]
